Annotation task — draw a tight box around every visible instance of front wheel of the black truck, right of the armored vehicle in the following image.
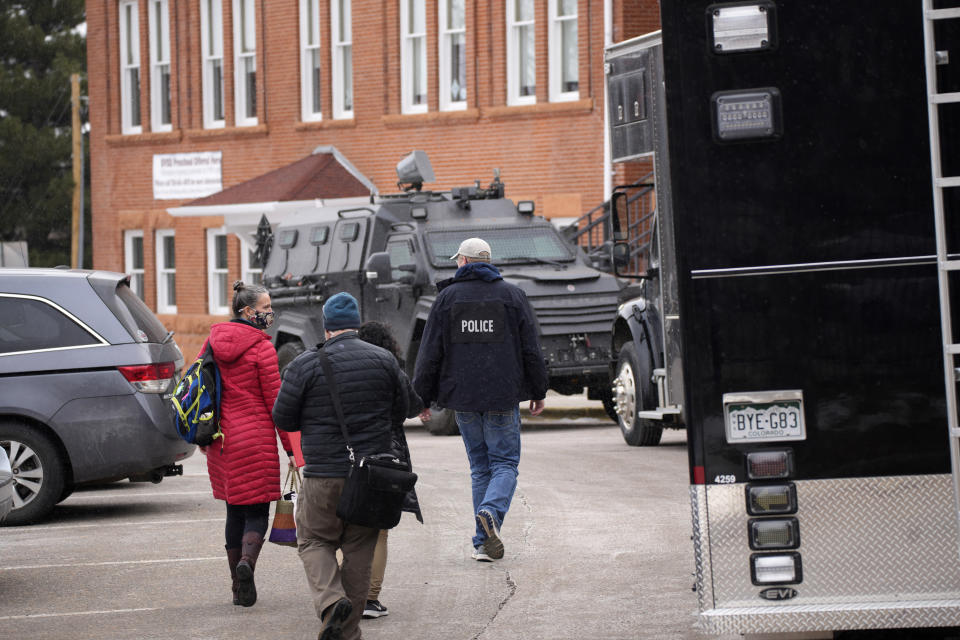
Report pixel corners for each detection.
[613,342,663,447]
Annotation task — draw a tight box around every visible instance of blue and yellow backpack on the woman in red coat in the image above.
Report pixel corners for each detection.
[170,342,223,447]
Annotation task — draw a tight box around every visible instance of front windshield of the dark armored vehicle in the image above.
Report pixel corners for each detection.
[427,226,573,266]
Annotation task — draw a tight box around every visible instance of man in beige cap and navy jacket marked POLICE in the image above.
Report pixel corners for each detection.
[413,238,548,562]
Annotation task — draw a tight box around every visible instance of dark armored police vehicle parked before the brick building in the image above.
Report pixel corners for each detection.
[258,151,620,434]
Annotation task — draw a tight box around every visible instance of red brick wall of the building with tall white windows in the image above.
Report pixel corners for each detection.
[87,0,659,357]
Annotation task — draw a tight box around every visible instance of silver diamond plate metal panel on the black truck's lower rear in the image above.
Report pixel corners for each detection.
[691,475,960,632]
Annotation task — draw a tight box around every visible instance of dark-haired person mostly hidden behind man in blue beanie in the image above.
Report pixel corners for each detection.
[357,321,423,618]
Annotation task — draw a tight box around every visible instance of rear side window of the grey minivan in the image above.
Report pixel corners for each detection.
[0,295,103,354]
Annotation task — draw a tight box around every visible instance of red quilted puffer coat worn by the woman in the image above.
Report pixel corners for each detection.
[198,322,293,504]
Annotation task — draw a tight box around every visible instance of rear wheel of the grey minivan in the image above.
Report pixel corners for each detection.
[0,422,64,526]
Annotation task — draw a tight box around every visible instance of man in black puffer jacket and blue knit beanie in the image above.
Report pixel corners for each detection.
[273,293,419,640]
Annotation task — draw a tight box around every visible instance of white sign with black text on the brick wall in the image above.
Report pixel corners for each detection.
[153,151,223,200]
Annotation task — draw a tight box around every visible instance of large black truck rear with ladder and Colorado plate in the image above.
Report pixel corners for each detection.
[607,0,960,637]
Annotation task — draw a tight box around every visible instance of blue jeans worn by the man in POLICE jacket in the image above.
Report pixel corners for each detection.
[457,408,520,547]
